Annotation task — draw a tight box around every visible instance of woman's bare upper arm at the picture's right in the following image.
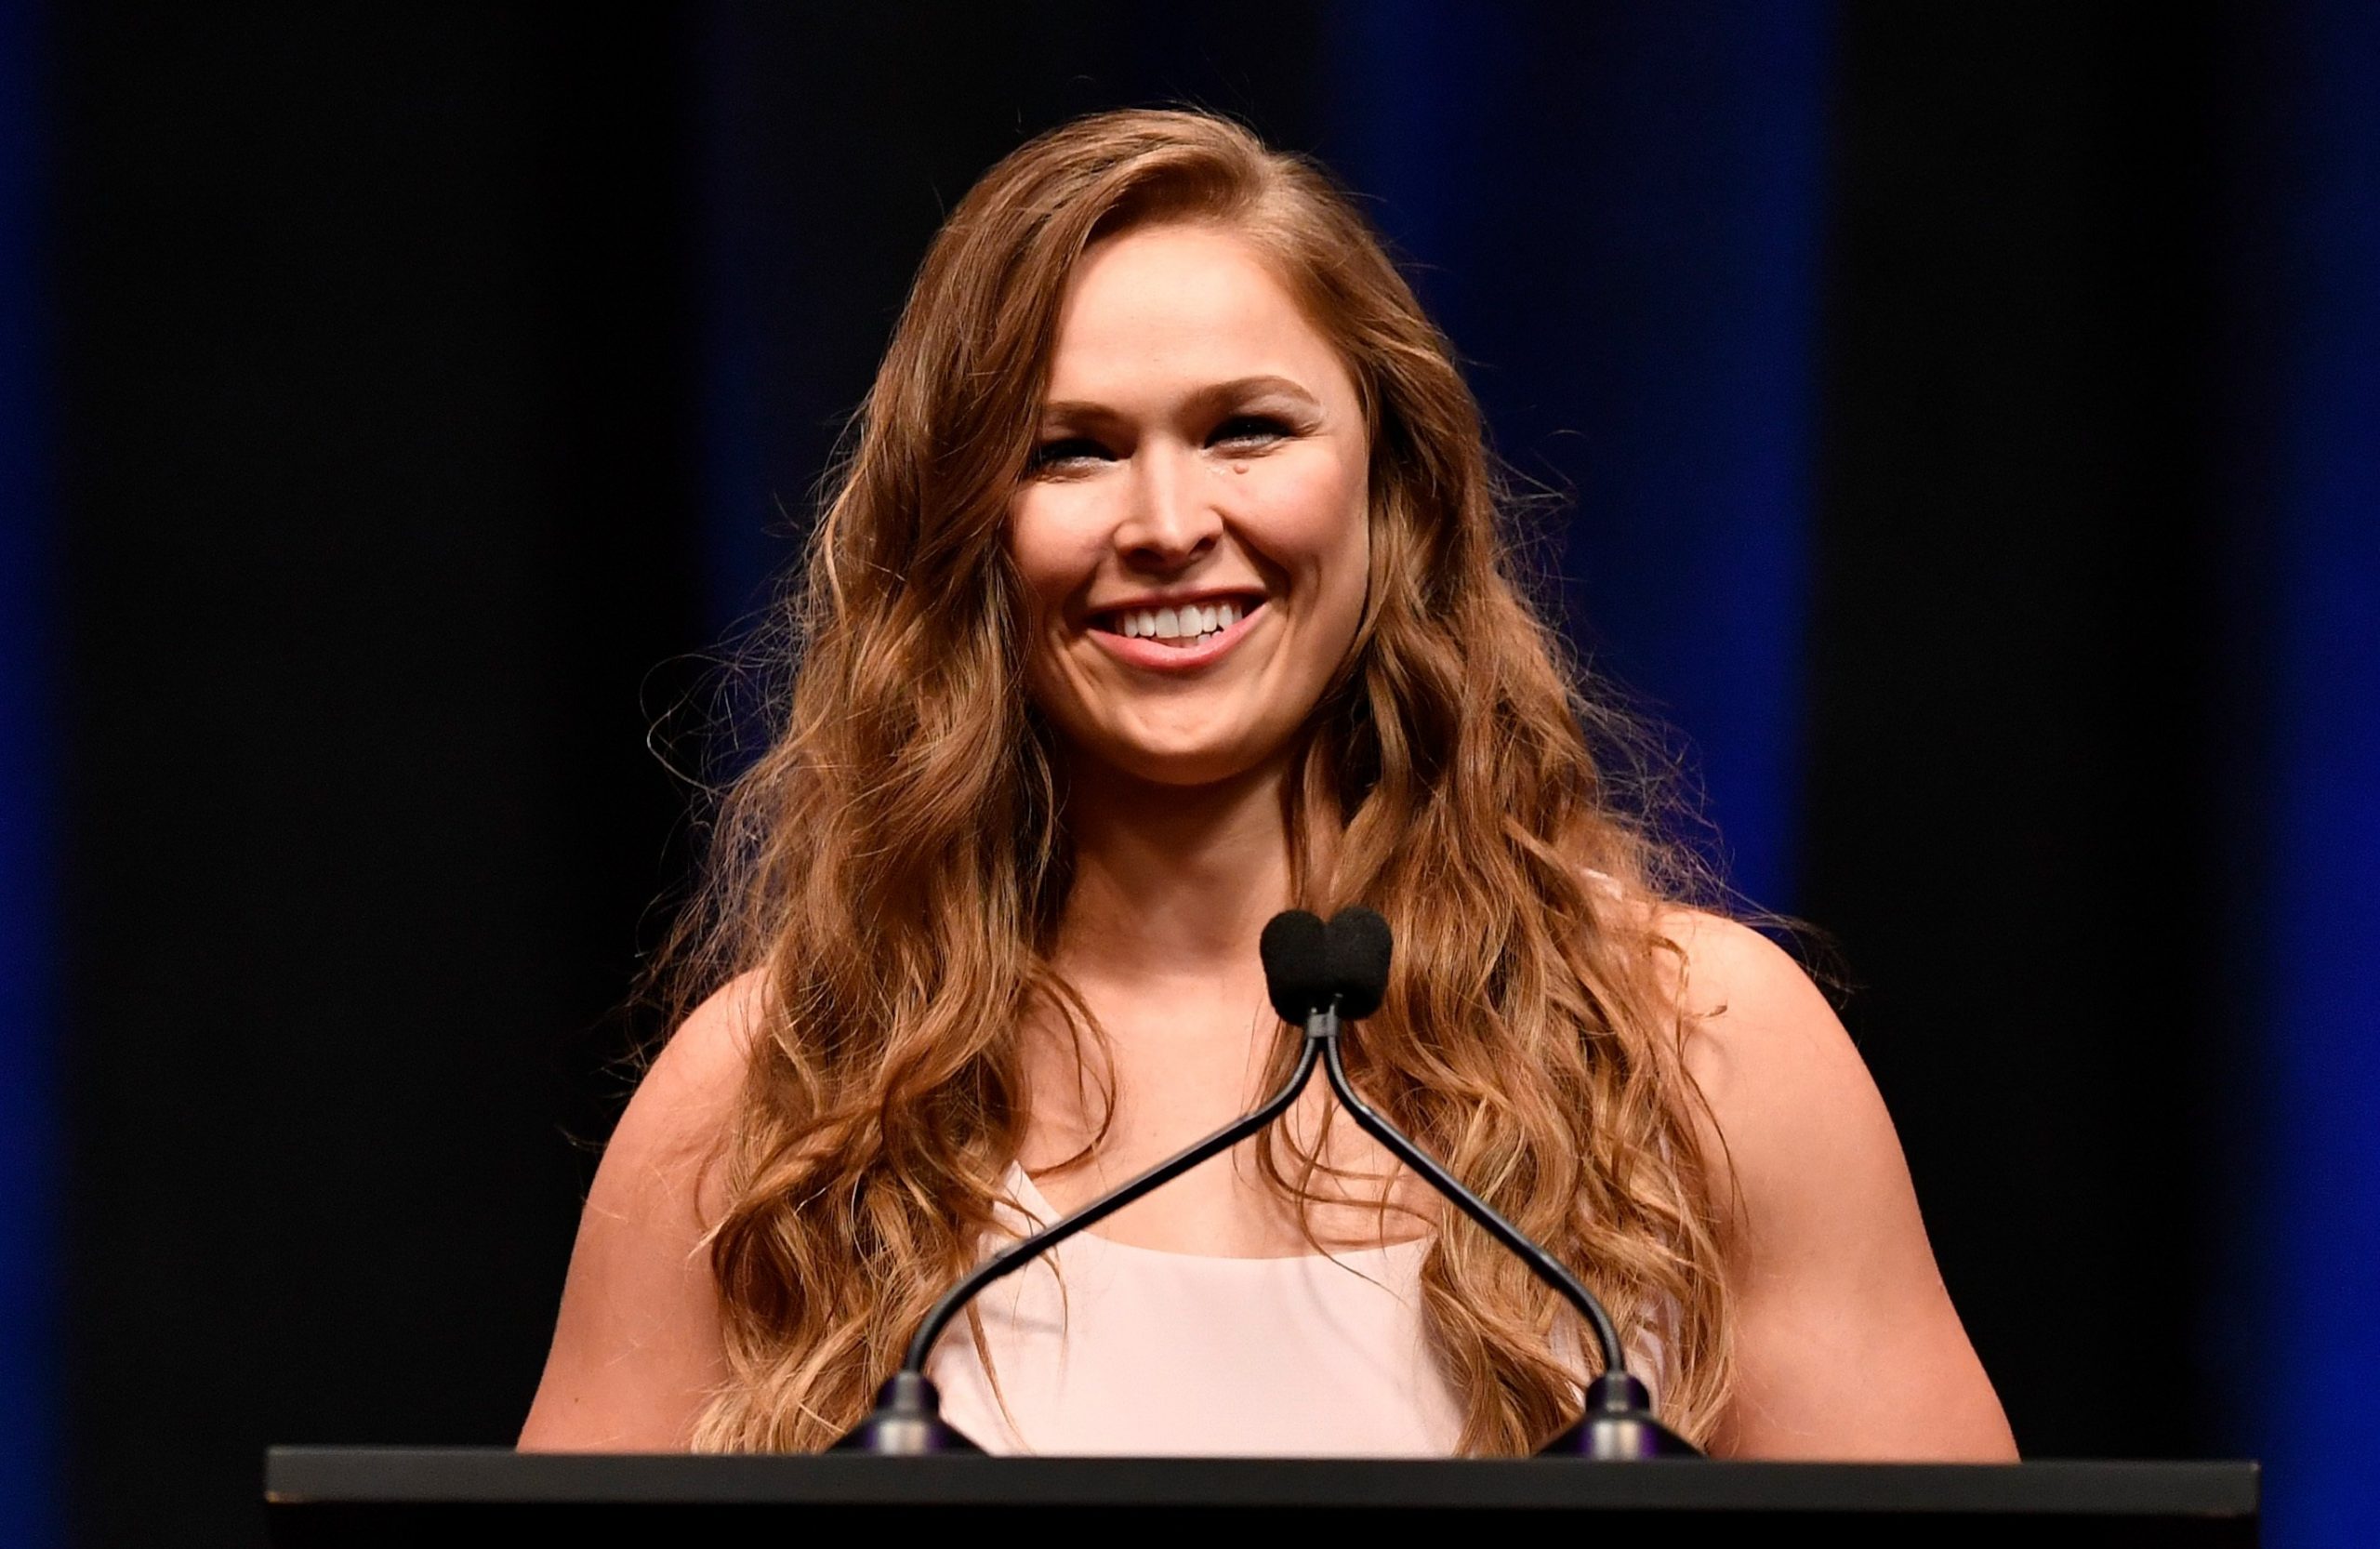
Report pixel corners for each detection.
[1673,916,2016,1461]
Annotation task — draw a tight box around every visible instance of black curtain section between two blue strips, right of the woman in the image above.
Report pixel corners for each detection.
[1799,7,2242,1456]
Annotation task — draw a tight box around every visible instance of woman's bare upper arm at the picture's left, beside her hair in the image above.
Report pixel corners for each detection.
[522,975,760,1451]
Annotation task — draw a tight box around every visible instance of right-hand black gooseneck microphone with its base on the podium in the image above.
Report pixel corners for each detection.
[1263,907,1701,1459]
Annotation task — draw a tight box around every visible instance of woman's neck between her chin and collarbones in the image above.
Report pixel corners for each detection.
[1057,759,1290,983]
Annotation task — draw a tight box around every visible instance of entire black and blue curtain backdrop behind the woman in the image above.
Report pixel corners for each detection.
[0,0,2380,1544]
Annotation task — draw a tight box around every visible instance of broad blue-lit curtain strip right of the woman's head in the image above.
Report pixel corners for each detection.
[1323,0,1832,907]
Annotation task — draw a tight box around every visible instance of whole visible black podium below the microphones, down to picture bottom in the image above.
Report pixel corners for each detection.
[264,1447,2258,1549]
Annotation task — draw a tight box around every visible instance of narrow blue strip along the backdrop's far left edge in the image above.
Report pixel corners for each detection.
[0,0,57,1544]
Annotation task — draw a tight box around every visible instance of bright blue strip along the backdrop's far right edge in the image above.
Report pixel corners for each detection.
[2235,0,2380,1549]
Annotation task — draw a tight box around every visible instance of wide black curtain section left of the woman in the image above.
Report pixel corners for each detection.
[55,5,700,1544]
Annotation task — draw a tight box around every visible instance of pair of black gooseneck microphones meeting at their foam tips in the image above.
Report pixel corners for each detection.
[836,909,1699,1459]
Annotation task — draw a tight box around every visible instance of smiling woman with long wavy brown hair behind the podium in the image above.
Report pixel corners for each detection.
[522,112,2014,1459]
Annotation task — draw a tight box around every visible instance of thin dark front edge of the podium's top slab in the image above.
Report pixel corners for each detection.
[264,1447,2261,1518]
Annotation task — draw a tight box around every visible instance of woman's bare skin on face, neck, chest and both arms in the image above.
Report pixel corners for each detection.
[522,226,2016,1461]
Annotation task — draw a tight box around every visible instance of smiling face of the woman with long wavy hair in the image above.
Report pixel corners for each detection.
[1009,226,1371,786]
